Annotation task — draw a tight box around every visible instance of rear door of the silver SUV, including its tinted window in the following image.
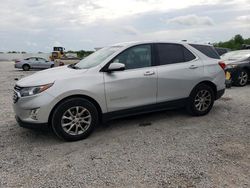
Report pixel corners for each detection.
[155,43,204,102]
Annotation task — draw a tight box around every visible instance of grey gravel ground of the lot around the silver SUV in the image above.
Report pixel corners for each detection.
[0,62,250,188]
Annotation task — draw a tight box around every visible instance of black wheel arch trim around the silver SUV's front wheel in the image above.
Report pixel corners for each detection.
[48,94,102,125]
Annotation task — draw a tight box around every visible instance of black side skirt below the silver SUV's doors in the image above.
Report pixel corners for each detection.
[102,98,188,122]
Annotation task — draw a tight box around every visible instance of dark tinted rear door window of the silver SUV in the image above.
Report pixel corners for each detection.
[156,43,196,65]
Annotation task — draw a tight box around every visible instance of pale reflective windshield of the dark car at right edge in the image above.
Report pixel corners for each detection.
[221,50,250,61]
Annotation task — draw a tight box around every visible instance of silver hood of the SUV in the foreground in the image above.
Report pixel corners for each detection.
[16,66,87,87]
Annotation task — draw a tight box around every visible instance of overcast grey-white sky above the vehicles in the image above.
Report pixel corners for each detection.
[0,0,250,52]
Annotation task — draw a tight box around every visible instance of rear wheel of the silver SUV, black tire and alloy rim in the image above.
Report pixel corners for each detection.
[186,84,215,116]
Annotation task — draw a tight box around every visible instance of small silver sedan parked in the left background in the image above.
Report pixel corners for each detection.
[14,57,54,71]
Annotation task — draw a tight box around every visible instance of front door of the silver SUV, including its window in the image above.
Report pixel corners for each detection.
[104,44,157,112]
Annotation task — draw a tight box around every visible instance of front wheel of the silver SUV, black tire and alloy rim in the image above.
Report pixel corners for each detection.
[51,98,98,141]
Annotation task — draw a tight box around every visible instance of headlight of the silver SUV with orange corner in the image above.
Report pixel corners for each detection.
[19,83,53,97]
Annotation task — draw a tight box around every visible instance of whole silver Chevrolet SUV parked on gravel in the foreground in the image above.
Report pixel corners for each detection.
[13,42,225,141]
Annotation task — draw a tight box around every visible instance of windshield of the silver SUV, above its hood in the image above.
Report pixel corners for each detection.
[75,46,122,69]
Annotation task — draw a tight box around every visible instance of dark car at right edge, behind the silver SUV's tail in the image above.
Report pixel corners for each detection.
[221,50,250,86]
